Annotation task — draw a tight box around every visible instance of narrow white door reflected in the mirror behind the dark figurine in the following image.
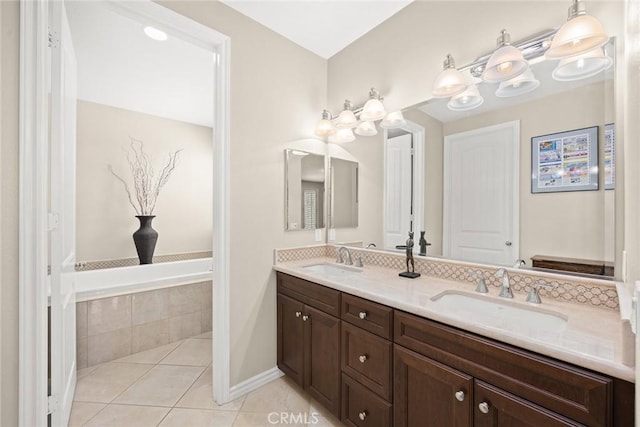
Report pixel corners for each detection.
[383,133,417,249]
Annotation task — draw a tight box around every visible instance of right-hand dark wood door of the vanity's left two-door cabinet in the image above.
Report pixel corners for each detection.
[304,306,340,417]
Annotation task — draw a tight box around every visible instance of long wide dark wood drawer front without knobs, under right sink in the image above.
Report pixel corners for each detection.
[394,310,613,426]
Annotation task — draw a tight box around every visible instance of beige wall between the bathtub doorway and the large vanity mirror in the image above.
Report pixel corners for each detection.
[162,1,327,385]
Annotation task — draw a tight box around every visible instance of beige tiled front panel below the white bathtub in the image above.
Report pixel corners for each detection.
[76,281,212,369]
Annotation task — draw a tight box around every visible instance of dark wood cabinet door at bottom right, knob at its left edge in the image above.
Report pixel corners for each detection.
[474,380,583,427]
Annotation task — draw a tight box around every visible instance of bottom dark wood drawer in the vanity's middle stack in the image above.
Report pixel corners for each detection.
[342,374,392,427]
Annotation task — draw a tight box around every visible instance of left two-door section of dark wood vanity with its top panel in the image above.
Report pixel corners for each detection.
[277,274,341,417]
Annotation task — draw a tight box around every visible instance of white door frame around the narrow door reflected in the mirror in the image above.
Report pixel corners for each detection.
[382,120,426,248]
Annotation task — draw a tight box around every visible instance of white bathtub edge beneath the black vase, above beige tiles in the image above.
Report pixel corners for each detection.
[73,258,213,302]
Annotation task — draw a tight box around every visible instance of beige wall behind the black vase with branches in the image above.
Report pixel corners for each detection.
[76,101,213,261]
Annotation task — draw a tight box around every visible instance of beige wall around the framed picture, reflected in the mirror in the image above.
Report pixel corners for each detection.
[444,82,614,265]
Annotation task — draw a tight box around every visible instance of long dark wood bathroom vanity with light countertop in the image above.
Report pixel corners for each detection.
[275,251,634,427]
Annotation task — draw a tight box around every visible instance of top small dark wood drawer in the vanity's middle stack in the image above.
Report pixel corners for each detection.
[342,294,393,340]
